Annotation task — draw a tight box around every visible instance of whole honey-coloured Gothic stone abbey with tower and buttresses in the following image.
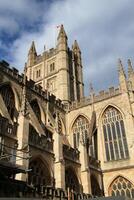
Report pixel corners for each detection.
[0,25,134,200]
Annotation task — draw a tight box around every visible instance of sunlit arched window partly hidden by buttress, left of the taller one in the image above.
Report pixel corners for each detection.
[72,115,89,148]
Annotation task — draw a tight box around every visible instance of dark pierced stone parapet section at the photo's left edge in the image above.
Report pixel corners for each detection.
[0,115,18,138]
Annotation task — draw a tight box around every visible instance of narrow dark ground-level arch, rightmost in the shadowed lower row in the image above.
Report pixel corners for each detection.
[91,175,102,197]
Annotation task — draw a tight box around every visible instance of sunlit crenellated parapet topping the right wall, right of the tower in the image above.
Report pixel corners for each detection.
[69,87,121,110]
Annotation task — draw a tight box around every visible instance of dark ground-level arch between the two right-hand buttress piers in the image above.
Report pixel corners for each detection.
[65,167,80,193]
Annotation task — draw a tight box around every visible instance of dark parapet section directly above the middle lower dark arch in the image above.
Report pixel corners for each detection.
[63,145,80,162]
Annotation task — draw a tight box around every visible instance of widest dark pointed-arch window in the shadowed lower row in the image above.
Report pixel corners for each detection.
[28,159,51,186]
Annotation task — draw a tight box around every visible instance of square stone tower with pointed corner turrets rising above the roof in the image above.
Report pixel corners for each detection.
[27,25,84,103]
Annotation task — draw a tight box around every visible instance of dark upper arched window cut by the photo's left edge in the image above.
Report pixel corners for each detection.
[0,85,15,120]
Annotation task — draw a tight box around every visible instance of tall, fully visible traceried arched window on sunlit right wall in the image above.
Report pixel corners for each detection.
[102,106,129,161]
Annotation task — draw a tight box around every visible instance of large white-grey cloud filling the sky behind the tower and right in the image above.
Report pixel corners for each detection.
[0,0,134,95]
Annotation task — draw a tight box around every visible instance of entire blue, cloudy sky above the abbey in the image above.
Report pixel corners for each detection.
[0,0,134,95]
